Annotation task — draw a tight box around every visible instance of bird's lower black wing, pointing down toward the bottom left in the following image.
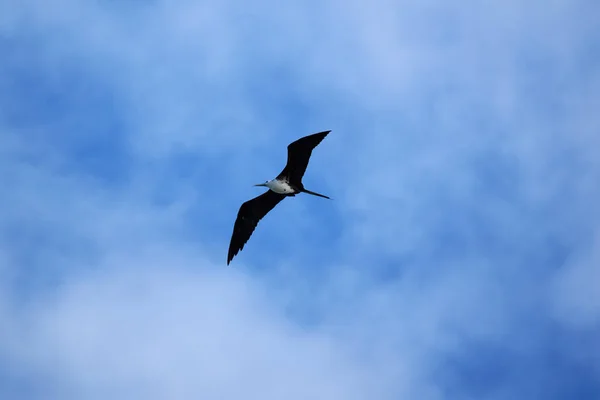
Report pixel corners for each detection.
[227,190,286,265]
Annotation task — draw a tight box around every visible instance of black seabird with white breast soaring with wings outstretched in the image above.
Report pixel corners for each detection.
[227,130,331,265]
